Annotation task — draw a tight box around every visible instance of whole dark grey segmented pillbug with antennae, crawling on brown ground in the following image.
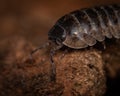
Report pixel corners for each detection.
[31,5,120,80]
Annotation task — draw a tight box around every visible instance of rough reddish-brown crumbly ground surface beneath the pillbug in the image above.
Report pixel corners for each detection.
[0,38,106,96]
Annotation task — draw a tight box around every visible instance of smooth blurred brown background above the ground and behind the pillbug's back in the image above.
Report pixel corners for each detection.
[0,0,120,45]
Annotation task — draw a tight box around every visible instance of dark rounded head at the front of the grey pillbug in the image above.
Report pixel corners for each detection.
[48,24,66,45]
